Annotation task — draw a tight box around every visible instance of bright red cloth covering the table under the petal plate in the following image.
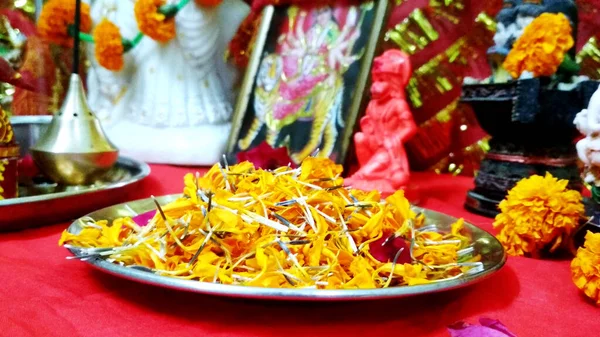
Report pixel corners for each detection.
[0,166,600,337]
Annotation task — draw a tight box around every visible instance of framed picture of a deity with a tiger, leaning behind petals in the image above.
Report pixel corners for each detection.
[228,0,389,165]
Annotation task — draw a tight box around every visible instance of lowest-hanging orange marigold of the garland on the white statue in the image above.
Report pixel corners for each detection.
[94,19,124,71]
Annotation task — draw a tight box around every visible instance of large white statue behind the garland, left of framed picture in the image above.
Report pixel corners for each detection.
[88,0,249,165]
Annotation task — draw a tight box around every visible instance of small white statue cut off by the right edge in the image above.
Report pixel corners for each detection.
[575,88,600,182]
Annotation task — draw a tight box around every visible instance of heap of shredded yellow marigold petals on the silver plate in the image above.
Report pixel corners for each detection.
[59,158,483,289]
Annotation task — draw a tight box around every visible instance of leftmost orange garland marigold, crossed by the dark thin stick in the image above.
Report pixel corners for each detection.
[37,0,92,47]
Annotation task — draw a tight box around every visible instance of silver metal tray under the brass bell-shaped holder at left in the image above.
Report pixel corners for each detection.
[0,116,150,231]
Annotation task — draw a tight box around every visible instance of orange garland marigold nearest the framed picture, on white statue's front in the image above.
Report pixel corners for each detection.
[134,0,175,42]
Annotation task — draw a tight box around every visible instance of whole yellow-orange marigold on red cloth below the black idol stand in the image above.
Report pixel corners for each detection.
[494,173,584,257]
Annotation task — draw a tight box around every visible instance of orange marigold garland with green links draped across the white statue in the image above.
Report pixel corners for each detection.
[38,0,222,71]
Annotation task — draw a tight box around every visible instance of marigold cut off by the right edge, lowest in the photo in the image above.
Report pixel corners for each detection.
[571,232,600,305]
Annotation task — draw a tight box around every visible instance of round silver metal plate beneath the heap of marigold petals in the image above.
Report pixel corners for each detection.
[68,195,506,301]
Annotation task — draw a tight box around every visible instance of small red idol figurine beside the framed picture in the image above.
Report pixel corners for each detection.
[346,49,417,195]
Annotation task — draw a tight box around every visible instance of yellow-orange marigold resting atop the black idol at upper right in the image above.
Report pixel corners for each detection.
[504,13,575,78]
